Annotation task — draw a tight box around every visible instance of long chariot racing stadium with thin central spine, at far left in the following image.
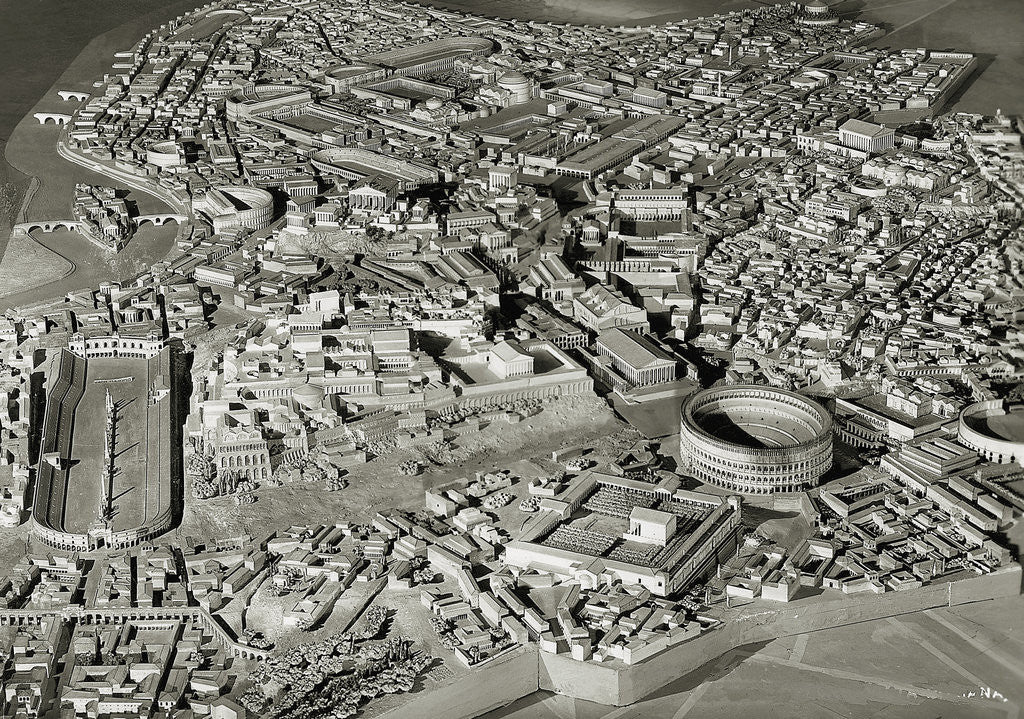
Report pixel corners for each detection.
[32,349,178,551]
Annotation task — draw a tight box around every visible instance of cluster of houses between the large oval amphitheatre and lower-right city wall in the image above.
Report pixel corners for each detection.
[725,450,1024,602]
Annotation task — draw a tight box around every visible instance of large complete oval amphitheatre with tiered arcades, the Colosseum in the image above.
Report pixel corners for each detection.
[679,384,833,495]
